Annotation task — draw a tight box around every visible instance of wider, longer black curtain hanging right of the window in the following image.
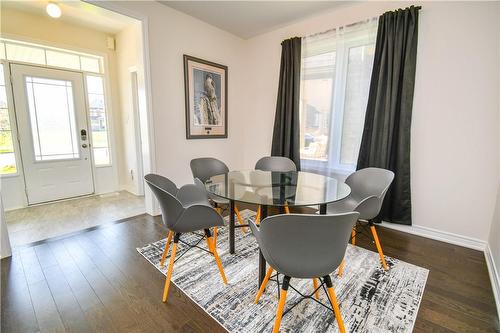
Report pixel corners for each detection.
[357,6,420,225]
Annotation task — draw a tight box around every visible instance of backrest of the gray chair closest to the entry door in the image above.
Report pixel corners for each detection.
[144,174,185,230]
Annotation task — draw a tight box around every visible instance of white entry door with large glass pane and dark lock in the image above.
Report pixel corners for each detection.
[11,64,94,204]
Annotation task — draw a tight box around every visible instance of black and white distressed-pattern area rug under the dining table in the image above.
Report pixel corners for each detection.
[137,210,429,333]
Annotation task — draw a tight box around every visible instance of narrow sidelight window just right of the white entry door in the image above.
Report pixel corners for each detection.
[86,75,111,166]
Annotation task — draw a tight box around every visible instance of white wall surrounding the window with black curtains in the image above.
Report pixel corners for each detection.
[241,2,500,241]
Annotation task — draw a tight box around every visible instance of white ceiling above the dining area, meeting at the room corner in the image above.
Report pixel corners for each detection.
[160,1,352,39]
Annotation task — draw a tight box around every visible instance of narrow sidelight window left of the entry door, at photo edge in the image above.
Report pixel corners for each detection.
[0,64,17,175]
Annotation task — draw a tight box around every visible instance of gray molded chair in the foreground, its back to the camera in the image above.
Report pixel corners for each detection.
[250,212,359,333]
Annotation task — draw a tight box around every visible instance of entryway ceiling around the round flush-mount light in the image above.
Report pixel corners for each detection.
[1,0,136,34]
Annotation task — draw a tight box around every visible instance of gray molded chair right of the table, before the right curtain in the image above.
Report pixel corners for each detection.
[327,168,394,270]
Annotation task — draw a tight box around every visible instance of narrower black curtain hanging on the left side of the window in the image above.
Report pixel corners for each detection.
[271,37,301,170]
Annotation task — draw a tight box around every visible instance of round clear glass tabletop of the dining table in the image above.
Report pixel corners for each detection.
[205,170,351,207]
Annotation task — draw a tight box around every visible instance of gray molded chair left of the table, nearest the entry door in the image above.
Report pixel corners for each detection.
[144,174,227,302]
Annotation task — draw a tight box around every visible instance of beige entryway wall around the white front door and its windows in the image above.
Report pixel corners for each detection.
[1,8,121,209]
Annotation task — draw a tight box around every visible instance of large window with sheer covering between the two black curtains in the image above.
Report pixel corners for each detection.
[300,20,377,174]
